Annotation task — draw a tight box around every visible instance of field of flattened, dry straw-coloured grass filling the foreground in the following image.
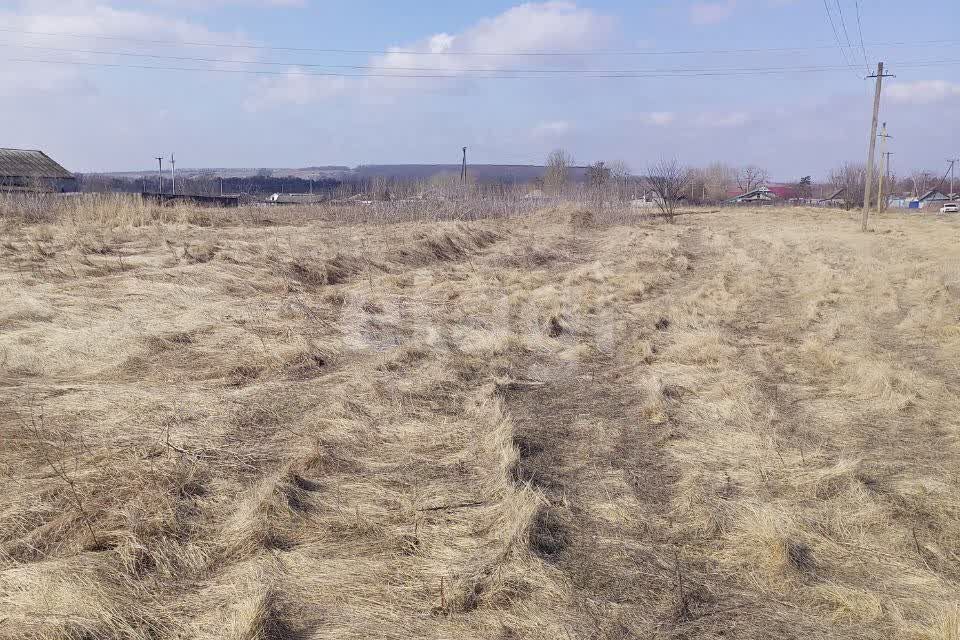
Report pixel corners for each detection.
[0,199,960,640]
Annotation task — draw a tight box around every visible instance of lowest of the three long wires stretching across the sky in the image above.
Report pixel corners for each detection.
[6,58,960,80]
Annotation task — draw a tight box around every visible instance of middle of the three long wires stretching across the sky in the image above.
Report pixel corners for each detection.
[0,42,952,75]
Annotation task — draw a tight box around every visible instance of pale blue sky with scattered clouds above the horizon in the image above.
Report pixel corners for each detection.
[0,0,960,181]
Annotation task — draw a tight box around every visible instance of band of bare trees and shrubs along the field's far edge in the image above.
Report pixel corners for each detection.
[78,149,946,215]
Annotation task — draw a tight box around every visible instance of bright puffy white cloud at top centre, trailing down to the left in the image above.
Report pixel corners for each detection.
[248,0,616,106]
